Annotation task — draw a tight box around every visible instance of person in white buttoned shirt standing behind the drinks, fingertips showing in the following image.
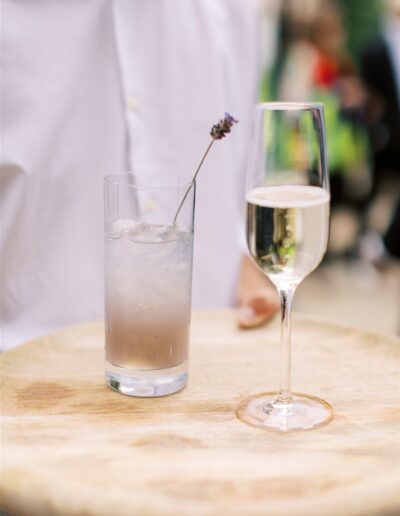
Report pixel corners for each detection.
[0,0,278,348]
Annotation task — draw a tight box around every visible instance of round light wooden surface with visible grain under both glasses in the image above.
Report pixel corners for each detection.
[1,311,400,516]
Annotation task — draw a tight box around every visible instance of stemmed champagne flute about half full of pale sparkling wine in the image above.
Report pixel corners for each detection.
[236,102,333,432]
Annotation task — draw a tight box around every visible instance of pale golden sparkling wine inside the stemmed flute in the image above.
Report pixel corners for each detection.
[246,185,330,285]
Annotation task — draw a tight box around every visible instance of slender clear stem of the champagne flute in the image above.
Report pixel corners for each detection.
[277,288,295,403]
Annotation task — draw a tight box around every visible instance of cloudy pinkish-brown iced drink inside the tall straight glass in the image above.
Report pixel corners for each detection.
[105,220,193,394]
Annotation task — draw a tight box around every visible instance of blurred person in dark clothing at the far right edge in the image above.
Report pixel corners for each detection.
[358,0,400,262]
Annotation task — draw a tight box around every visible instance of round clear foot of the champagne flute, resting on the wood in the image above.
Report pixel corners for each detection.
[236,392,333,432]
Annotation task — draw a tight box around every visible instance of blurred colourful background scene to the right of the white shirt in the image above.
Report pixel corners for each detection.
[260,0,400,333]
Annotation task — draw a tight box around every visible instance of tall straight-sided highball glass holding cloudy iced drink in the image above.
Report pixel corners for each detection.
[105,173,195,397]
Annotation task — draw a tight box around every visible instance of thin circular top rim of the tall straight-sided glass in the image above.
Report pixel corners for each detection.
[104,171,193,190]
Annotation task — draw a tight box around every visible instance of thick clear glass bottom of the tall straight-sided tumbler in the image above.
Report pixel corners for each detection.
[106,362,187,398]
